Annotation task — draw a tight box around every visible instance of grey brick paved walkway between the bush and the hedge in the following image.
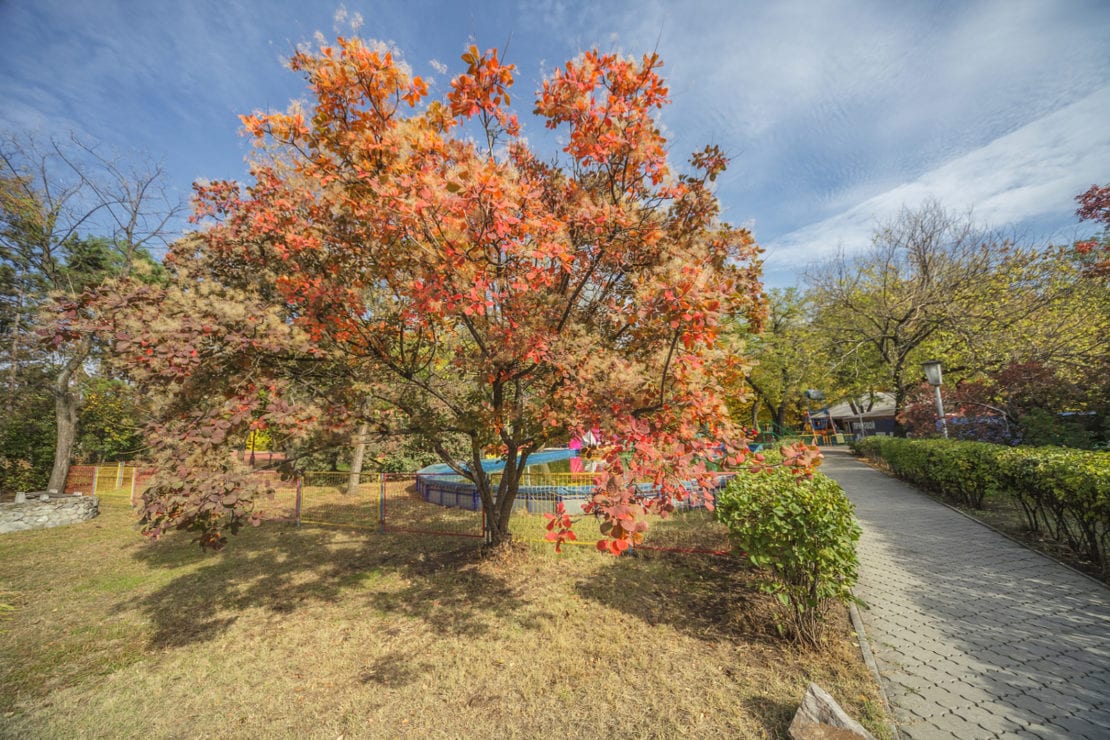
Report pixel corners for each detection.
[821,448,1110,740]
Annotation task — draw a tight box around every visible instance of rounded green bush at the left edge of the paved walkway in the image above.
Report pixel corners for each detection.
[717,468,860,645]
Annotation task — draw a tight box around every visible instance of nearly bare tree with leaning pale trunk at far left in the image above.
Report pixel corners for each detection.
[0,135,179,490]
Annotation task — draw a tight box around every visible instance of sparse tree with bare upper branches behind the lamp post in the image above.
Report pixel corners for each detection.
[807,202,1036,437]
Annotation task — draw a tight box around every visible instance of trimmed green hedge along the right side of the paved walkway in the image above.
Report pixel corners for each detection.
[852,437,1110,574]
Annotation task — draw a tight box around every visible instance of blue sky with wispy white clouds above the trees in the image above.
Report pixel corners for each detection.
[0,0,1110,286]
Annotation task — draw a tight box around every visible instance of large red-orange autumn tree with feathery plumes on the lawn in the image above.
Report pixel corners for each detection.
[86,38,811,551]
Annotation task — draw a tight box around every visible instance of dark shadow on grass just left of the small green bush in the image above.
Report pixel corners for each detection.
[576,550,774,641]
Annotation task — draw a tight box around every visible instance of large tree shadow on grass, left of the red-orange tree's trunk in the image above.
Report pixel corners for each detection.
[118,523,521,648]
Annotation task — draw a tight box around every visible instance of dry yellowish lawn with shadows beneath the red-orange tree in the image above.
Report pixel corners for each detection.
[0,488,884,738]
